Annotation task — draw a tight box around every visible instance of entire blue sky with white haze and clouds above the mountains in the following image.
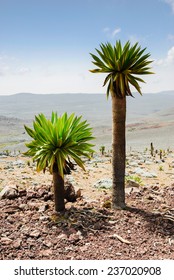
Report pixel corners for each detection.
[0,0,174,95]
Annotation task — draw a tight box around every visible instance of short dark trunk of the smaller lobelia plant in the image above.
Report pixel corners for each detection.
[53,164,65,212]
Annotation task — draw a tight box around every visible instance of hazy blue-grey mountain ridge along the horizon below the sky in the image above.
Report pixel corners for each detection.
[0,91,174,124]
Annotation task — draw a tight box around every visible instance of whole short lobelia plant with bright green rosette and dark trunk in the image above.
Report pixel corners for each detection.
[24,112,94,211]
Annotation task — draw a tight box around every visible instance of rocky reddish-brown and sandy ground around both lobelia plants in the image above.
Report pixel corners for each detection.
[0,150,174,260]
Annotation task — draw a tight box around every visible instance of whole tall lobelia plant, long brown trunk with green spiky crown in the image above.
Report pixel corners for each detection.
[90,41,153,209]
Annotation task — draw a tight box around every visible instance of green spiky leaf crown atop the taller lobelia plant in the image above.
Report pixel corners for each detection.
[90,41,153,98]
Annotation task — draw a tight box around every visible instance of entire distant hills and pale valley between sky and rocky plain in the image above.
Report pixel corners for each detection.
[0,91,174,150]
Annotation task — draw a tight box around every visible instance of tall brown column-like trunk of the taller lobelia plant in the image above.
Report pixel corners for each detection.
[112,94,126,209]
